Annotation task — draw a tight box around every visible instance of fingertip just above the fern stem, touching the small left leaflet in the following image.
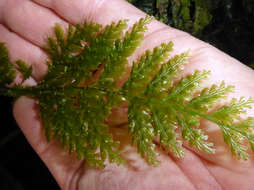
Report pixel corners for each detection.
[0,24,47,81]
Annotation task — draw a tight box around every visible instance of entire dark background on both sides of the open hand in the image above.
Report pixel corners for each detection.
[0,0,254,190]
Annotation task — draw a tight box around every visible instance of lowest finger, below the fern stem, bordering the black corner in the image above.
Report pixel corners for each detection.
[13,97,83,189]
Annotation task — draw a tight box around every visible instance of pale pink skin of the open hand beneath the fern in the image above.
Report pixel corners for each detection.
[0,0,254,190]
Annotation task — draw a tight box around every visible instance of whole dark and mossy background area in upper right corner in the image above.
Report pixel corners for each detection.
[128,0,254,64]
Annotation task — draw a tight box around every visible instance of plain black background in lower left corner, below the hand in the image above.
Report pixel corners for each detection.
[0,97,59,190]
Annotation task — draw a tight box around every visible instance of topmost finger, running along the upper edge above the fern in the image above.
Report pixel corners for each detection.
[33,0,158,30]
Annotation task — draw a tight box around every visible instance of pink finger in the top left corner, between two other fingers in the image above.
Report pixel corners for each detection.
[0,0,67,47]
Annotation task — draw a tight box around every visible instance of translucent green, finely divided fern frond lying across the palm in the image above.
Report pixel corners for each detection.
[0,17,254,167]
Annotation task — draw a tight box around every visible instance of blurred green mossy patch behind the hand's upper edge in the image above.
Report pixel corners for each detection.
[129,0,214,35]
